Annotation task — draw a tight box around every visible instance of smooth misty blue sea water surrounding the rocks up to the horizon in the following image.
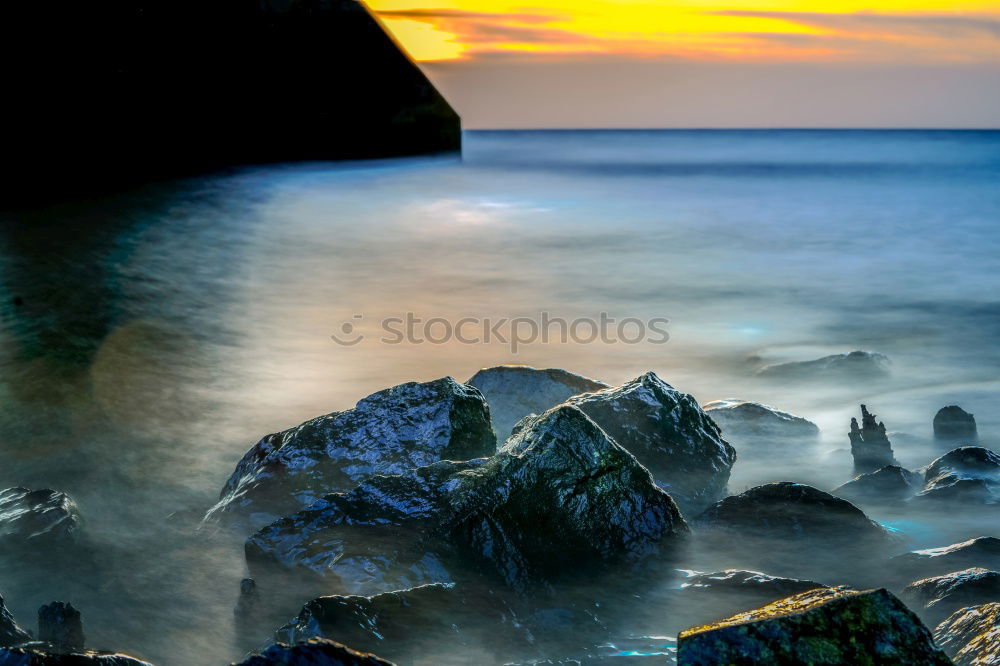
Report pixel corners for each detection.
[0,131,1000,664]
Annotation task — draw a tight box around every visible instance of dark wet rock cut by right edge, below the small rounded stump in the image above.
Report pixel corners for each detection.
[914,446,1000,505]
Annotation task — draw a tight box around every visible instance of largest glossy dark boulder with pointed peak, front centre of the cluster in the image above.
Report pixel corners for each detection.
[247,405,688,594]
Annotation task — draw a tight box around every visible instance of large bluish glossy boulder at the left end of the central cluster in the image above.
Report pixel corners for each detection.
[206,377,496,528]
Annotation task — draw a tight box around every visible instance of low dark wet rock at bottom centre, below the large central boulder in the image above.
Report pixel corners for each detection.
[275,585,526,664]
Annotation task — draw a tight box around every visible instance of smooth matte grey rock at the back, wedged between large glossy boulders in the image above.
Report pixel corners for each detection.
[466,365,608,442]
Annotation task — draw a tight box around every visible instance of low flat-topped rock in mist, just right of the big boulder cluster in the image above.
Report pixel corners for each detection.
[704,400,819,445]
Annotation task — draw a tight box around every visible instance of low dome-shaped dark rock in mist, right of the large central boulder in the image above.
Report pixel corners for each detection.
[698,481,888,548]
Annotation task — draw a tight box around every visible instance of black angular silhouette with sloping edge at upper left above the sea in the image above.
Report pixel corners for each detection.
[0,0,460,200]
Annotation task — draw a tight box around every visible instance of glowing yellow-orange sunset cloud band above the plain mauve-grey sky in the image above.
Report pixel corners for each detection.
[368,0,1000,63]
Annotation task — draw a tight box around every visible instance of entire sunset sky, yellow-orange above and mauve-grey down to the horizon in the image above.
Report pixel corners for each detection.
[367,0,1000,129]
